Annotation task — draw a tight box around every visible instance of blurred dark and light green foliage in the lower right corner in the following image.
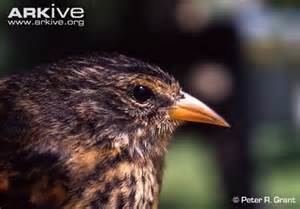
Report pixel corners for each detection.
[251,124,300,209]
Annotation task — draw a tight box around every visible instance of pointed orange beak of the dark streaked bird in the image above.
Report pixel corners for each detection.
[169,92,230,127]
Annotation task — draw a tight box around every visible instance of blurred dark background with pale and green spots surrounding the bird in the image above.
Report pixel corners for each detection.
[0,0,300,209]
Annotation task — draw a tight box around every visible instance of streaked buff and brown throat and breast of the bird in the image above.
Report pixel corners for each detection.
[60,130,169,209]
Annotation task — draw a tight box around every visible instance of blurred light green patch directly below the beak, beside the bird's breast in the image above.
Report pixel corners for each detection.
[161,135,223,209]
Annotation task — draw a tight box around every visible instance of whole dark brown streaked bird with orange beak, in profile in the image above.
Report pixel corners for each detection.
[0,54,229,209]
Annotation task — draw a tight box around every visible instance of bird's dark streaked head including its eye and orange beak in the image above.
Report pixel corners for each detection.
[21,55,229,160]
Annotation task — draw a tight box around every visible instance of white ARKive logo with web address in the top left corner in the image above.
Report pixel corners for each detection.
[7,3,85,26]
